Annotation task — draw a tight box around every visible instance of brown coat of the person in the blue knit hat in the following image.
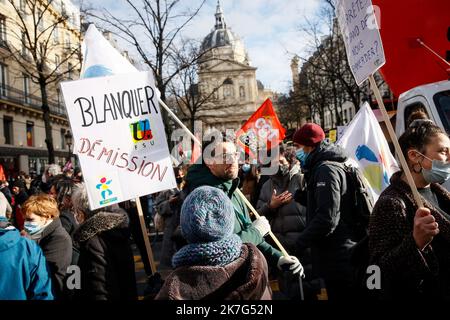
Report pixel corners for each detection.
[156,243,272,300]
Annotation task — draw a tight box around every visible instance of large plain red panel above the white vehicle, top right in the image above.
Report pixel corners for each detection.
[372,0,450,96]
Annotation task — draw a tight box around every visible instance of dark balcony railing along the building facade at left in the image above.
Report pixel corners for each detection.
[0,84,67,117]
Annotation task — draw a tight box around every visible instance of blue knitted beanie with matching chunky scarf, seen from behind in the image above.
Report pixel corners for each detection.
[172,186,242,268]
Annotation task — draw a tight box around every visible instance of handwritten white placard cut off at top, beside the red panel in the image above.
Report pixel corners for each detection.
[336,0,386,86]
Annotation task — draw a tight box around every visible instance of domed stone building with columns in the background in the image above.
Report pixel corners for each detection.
[198,1,273,130]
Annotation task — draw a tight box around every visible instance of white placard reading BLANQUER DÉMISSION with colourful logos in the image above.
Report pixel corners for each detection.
[61,72,176,210]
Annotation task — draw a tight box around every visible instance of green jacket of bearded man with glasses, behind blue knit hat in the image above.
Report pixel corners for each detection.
[185,164,282,266]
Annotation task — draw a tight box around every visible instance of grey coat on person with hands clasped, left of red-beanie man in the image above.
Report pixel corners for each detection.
[256,164,306,256]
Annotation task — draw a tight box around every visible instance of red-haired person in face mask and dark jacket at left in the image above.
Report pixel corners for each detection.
[22,194,72,299]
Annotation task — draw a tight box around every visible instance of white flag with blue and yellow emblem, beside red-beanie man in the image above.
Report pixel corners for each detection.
[336,102,399,201]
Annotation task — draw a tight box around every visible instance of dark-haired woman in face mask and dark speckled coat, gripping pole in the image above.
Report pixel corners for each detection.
[369,122,450,299]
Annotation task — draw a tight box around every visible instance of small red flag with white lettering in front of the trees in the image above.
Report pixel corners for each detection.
[236,99,286,159]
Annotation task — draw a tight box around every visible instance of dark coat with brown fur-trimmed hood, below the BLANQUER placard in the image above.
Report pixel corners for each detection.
[73,210,137,301]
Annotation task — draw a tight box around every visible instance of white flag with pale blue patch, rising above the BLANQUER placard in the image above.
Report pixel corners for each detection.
[80,24,138,79]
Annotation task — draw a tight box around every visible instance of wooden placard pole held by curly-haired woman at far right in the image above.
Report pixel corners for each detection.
[369,74,423,208]
